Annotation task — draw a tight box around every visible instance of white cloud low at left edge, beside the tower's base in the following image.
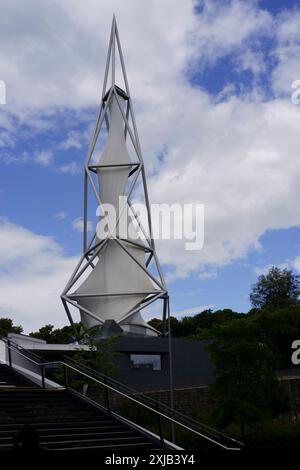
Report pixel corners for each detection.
[0,218,78,333]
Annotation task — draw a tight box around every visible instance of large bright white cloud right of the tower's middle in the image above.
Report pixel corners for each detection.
[149,90,300,277]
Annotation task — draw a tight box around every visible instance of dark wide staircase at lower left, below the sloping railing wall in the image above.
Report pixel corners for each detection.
[0,365,161,451]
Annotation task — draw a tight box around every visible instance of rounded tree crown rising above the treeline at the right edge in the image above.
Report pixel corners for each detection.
[250,266,300,309]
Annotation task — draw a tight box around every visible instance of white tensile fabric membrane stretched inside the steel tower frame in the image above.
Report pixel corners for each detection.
[76,95,155,334]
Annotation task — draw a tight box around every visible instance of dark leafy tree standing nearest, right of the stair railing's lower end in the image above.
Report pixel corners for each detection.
[208,319,289,439]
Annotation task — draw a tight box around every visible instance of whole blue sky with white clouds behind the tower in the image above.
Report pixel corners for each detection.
[0,0,300,331]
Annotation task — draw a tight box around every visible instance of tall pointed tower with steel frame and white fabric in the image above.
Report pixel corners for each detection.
[61,17,169,336]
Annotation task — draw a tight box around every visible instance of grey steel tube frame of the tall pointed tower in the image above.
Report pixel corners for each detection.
[61,15,170,334]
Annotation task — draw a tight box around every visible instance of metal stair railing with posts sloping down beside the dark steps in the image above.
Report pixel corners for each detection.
[2,339,243,450]
